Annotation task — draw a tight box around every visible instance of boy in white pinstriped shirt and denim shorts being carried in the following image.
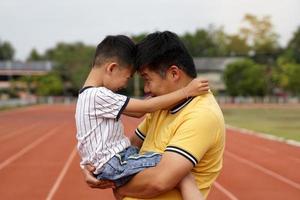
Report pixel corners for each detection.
[75,35,208,199]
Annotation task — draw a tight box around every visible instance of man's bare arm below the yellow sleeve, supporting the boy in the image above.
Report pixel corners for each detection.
[117,152,193,198]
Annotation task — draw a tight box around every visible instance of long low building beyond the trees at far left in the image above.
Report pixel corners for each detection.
[0,61,53,89]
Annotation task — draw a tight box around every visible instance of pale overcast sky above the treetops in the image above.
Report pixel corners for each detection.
[0,0,300,60]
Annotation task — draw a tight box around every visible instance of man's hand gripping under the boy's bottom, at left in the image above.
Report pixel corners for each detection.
[82,165,116,189]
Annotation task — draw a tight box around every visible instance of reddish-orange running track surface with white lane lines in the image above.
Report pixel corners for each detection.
[0,105,300,200]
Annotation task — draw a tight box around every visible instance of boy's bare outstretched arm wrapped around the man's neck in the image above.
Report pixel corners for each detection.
[123,79,209,114]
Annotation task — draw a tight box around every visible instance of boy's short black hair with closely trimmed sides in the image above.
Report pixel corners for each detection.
[93,35,136,66]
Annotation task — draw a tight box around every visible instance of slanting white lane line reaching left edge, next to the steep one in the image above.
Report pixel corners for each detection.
[0,126,62,170]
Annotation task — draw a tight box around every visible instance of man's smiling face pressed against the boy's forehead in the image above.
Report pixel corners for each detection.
[140,67,174,97]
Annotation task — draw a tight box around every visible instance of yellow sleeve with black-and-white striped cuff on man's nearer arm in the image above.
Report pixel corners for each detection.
[165,112,220,166]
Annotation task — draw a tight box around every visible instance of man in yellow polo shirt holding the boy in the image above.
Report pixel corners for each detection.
[85,31,225,200]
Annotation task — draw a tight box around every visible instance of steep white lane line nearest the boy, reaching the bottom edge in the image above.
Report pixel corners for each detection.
[46,146,77,200]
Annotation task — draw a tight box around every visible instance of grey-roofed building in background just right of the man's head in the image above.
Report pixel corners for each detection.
[194,57,242,93]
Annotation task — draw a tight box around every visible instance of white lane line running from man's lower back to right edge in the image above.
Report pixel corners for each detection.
[225,151,300,190]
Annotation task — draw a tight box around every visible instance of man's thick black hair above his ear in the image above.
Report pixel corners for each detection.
[136,31,197,78]
